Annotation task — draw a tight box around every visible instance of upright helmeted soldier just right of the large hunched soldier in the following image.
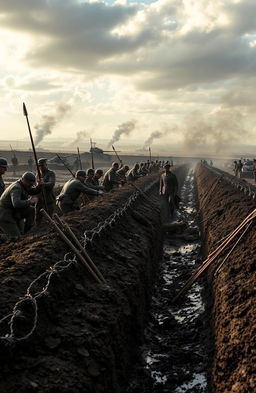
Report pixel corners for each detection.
[36,158,56,225]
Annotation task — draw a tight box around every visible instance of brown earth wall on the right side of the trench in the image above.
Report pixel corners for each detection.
[196,165,256,393]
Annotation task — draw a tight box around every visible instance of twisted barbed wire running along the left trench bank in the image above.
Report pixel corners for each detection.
[0,179,158,345]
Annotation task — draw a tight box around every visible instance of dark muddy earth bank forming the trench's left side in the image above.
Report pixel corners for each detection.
[0,167,187,393]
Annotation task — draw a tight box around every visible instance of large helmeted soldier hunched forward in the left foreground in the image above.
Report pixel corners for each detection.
[0,172,41,239]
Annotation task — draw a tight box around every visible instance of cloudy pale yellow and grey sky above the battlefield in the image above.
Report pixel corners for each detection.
[0,0,256,154]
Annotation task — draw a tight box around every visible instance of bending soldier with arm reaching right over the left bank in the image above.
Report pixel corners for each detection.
[57,170,103,214]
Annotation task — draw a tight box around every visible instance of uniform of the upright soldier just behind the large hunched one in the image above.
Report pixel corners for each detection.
[36,169,56,224]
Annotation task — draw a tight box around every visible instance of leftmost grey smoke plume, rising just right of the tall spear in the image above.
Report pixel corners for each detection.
[35,104,71,146]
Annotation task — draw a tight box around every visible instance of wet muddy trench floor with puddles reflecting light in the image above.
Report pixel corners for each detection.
[127,169,209,393]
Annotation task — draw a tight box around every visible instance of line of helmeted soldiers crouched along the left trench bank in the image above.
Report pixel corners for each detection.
[0,157,172,239]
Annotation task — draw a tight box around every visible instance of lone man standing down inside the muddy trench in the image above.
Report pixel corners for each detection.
[159,164,178,217]
